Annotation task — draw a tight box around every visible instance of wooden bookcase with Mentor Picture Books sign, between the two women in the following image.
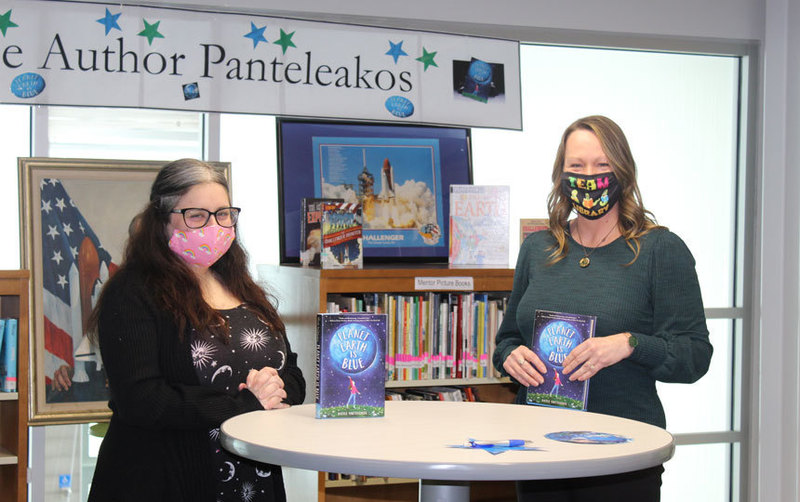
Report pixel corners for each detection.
[258,264,515,502]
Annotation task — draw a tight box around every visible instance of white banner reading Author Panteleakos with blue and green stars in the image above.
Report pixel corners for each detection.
[0,0,522,129]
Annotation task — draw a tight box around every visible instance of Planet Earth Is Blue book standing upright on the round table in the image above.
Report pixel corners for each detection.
[315,312,386,418]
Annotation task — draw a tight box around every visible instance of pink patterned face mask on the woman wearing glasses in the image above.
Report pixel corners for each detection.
[169,225,236,268]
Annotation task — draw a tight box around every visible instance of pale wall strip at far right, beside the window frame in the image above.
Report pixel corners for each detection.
[757,0,800,501]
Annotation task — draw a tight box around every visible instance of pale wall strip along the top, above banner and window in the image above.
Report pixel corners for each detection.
[144,0,764,40]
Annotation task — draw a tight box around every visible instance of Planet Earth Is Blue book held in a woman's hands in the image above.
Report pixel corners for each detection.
[526,310,597,410]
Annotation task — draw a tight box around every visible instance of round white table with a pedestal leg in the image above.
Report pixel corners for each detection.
[221,401,674,501]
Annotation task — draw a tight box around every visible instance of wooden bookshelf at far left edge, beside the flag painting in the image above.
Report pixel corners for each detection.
[0,270,30,502]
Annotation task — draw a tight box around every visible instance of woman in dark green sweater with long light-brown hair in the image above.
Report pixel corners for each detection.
[493,116,712,502]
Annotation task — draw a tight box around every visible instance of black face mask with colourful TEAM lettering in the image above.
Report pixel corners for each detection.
[561,172,619,220]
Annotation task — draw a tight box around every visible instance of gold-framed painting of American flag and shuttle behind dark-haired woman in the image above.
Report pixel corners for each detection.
[18,157,230,425]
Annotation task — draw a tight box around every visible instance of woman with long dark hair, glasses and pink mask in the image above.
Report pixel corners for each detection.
[89,159,305,502]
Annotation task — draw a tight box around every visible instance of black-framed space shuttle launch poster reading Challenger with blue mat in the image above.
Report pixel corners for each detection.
[277,118,472,263]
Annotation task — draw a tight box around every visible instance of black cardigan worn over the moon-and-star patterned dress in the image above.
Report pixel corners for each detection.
[89,269,305,502]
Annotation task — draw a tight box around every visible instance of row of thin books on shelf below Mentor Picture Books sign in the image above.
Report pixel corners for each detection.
[327,292,508,381]
